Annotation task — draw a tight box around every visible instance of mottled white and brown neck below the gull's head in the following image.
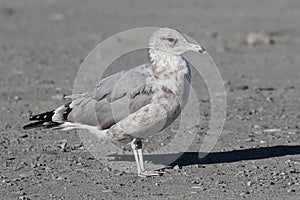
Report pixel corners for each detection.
[148,49,190,75]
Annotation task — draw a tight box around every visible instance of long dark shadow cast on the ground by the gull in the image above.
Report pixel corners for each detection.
[110,145,300,167]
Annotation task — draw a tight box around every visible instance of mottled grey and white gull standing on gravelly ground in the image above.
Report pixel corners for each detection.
[23,27,206,177]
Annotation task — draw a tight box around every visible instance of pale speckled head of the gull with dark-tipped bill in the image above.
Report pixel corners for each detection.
[149,28,205,56]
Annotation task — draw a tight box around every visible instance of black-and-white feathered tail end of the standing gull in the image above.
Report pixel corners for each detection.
[23,104,72,129]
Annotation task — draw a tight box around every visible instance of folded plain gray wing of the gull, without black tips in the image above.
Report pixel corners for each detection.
[68,65,152,129]
